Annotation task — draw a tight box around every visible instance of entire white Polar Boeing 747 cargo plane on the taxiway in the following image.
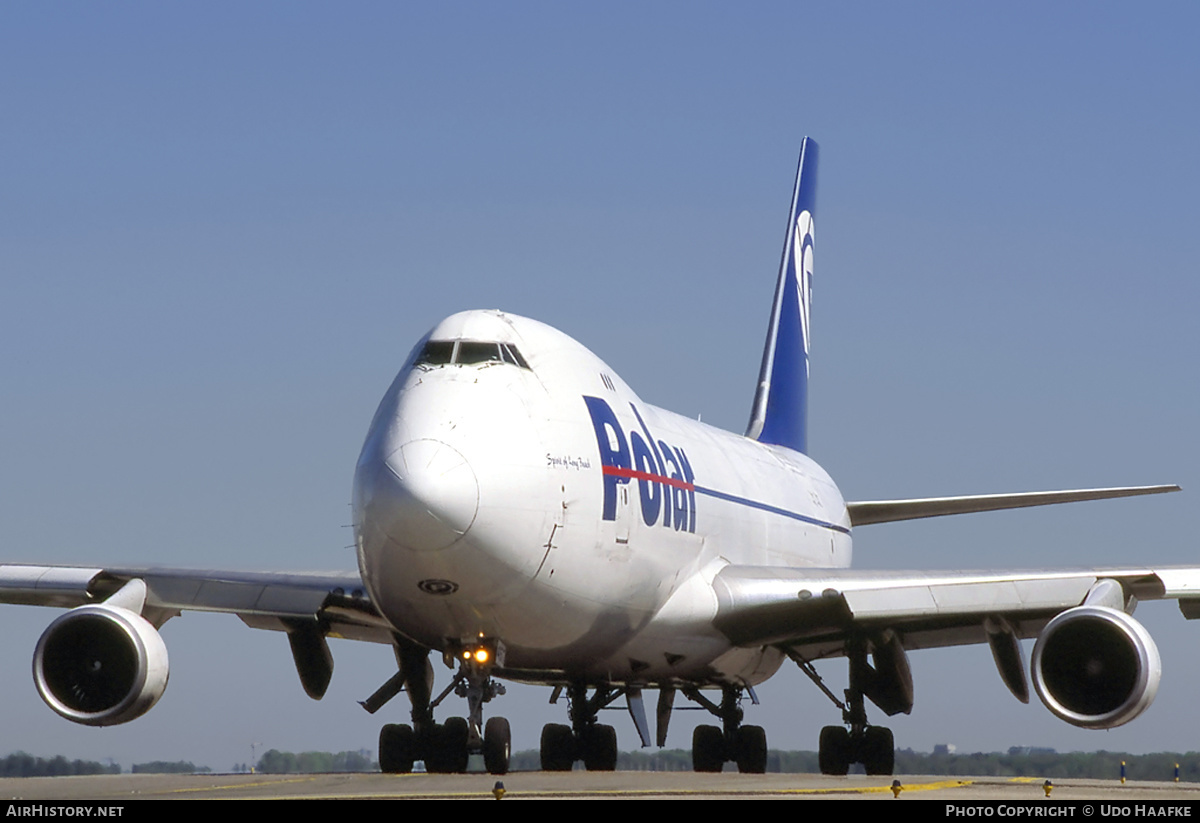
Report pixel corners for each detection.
[0,139,1200,774]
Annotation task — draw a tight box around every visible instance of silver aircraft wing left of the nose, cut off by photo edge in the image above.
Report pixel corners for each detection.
[0,565,391,644]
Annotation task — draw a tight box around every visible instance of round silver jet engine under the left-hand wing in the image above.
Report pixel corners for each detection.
[34,603,168,726]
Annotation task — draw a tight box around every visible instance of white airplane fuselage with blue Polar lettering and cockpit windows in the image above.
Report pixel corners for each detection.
[354,311,851,684]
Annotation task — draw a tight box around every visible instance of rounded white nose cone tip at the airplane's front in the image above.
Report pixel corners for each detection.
[365,439,479,552]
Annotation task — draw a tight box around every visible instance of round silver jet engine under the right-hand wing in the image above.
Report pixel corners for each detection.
[1033,606,1163,728]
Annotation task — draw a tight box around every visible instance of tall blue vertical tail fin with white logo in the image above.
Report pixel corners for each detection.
[746,137,817,453]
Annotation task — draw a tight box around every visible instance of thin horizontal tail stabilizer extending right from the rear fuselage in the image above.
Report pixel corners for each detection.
[846,486,1180,525]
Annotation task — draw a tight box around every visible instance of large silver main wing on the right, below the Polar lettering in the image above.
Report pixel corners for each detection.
[713,565,1200,660]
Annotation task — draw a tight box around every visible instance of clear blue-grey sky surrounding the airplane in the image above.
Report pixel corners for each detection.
[0,2,1200,769]
